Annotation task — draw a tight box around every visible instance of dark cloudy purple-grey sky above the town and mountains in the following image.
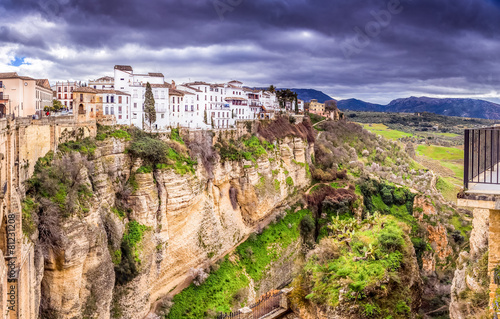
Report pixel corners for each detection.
[0,0,500,103]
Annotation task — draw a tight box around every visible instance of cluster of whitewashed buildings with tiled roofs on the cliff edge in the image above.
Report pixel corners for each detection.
[84,65,279,131]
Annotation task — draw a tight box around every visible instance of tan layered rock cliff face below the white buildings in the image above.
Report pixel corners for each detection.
[36,138,312,319]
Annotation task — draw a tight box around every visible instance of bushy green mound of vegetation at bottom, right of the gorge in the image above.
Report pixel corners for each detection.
[292,216,412,318]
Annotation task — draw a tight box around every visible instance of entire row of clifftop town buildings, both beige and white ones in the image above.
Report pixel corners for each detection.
[0,65,336,132]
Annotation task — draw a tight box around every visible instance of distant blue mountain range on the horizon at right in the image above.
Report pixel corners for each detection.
[338,96,500,120]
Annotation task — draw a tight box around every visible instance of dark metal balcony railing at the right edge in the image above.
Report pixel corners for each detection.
[464,127,500,189]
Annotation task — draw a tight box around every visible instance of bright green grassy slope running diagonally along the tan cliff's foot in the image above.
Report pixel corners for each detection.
[167,210,310,318]
